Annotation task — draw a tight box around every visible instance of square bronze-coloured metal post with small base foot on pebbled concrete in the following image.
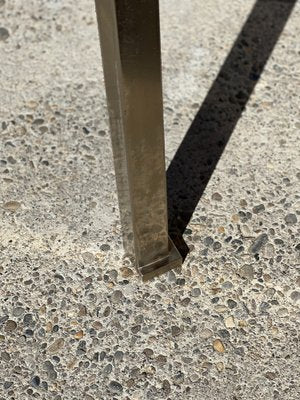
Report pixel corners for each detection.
[95,0,181,280]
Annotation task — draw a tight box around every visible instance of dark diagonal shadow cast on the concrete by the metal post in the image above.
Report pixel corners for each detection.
[167,0,296,257]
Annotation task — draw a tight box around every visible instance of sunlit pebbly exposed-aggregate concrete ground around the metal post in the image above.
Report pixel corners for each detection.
[0,0,300,400]
